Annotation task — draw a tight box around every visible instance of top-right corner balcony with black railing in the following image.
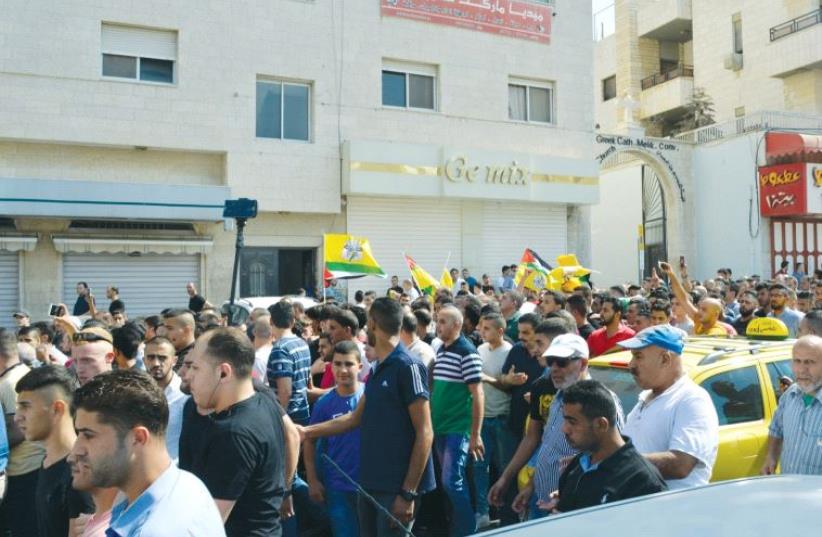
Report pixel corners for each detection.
[764,8,822,78]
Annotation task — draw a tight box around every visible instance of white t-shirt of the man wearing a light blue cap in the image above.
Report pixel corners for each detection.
[622,375,719,489]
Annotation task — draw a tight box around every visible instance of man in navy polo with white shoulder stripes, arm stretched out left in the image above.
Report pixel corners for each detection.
[299,297,434,537]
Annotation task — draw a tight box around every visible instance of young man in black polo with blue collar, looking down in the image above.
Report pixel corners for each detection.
[539,380,668,513]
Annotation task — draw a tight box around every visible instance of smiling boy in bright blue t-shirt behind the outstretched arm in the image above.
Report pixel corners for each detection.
[303,341,364,537]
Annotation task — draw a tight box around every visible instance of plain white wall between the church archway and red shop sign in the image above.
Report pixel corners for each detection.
[691,133,770,278]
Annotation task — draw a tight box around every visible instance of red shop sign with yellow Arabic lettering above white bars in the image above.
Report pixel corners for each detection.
[759,163,808,216]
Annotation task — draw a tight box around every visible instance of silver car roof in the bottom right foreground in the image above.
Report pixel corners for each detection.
[483,475,822,537]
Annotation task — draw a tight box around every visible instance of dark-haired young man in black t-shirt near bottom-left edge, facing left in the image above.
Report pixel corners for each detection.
[14,365,94,537]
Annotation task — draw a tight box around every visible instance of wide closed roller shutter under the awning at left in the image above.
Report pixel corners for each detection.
[63,254,200,318]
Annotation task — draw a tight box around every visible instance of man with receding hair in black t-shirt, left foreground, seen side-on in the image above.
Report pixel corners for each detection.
[180,328,286,537]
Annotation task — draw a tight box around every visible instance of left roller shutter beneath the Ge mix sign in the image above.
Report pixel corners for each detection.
[347,197,462,296]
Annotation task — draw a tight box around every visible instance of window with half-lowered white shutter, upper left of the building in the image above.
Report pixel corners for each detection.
[101,23,177,84]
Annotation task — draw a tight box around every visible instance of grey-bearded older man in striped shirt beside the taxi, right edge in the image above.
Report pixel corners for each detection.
[762,336,822,475]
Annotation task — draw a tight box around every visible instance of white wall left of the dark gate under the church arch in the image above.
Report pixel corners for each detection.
[591,165,642,287]
